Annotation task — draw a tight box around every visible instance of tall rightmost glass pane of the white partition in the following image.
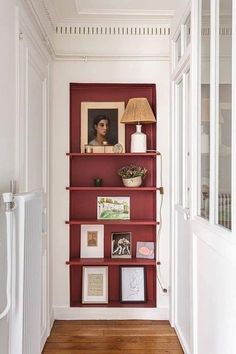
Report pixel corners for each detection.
[218,0,232,229]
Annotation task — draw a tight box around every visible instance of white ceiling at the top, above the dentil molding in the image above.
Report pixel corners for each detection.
[43,0,177,25]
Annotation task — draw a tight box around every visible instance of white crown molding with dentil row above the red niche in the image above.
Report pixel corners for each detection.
[19,0,170,61]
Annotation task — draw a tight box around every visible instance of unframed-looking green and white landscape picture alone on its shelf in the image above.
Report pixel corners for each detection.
[97,196,130,220]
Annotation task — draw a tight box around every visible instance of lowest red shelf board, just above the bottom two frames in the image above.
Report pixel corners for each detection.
[66,258,156,266]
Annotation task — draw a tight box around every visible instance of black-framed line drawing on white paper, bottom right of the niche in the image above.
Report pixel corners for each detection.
[120,266,146,302]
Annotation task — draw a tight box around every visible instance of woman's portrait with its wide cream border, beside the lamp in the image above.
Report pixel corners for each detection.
[81,102,125,152]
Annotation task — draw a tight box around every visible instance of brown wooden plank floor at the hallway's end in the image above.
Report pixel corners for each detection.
[43,320,183,354]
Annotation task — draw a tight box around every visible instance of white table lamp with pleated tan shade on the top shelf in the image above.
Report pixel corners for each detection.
[120,98,156,152]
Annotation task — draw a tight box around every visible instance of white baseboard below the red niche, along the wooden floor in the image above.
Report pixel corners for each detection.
[53,306,169,320]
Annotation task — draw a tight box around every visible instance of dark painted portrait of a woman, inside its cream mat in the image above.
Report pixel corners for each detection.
[88,109,118,146]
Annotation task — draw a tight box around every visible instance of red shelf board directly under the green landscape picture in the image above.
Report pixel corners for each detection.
[65,219,159,225]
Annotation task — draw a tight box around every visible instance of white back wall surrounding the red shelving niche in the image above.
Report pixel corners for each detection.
[50,59,169,319]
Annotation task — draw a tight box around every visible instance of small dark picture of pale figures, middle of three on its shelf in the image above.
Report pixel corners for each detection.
[111,232,132,258]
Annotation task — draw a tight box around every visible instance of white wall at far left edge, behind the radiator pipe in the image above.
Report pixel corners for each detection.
[0,0,16,354]
